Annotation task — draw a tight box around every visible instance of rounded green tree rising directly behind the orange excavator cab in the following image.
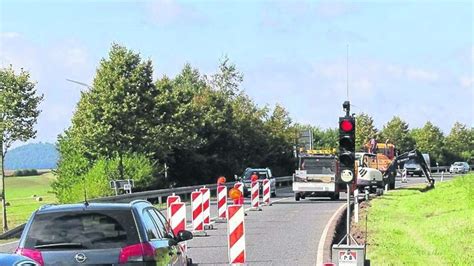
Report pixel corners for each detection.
[378,116,415,152]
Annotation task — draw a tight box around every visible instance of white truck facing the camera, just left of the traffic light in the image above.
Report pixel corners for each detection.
[293,151,340,201]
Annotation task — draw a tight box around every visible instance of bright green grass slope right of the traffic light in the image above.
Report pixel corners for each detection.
[359,174,474,265]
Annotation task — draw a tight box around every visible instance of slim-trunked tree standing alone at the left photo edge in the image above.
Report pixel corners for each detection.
[0,66,43,231]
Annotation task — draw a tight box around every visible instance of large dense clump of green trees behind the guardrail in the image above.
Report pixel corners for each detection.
[53,44,297,202]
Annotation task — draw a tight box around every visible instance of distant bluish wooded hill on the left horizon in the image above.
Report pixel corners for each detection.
[5,142,59,170]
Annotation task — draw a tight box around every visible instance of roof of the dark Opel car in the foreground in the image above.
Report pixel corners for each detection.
[37,200,151,214]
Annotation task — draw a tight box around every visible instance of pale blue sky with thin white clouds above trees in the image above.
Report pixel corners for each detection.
[0,0,474,147]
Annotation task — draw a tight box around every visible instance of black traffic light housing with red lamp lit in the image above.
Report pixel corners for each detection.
[339,113,355,183]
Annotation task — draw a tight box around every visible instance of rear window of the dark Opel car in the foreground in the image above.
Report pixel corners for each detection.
[25,210,139,249]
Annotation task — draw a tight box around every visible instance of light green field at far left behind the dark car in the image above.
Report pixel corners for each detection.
[0,173,56,229]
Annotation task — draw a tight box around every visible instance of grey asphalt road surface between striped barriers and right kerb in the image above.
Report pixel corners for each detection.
[188,188,344,265]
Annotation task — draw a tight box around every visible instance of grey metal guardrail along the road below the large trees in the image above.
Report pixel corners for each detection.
[90,176,293,204]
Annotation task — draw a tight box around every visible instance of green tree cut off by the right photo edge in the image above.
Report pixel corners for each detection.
[446,122,474,161]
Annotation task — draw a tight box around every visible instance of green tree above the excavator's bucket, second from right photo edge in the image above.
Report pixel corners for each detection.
[410,121,446,164]
